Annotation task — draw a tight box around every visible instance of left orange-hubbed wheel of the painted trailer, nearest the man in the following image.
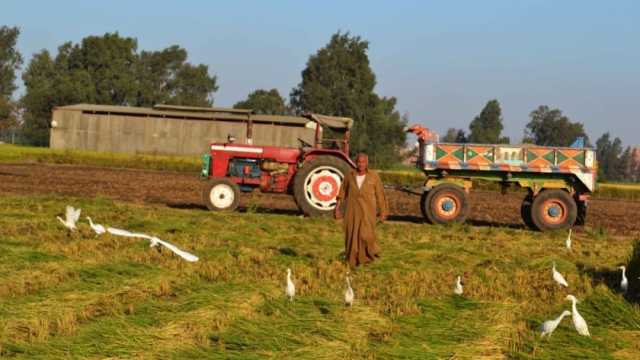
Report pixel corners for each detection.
[421,184,469,224]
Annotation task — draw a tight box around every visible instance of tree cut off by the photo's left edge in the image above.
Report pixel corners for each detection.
[0,26,22,128]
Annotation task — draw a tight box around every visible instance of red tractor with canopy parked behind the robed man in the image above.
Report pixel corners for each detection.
[201,114,355,216]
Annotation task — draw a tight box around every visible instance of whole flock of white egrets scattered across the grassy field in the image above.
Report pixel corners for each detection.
[57,206,640,337]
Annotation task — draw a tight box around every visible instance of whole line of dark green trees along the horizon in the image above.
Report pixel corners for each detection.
[0,26,640,176]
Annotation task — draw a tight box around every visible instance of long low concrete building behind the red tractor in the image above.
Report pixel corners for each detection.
[50,104,316,155]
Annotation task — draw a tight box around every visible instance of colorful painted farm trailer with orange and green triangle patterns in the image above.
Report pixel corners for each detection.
[409,126,597,231]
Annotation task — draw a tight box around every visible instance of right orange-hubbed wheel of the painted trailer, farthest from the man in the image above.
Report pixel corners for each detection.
[531,189,578,231]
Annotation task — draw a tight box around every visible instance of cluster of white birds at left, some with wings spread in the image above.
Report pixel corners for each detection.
[57,206,198,262]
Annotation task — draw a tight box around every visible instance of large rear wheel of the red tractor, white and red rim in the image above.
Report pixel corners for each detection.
[293,156,349,216]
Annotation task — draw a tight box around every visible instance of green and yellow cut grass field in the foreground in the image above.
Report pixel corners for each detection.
[0,196,640,359]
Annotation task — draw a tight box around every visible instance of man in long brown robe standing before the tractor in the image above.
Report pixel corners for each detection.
[335,154,388,266]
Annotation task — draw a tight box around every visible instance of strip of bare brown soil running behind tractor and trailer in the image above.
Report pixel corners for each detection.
[0,164,640,235]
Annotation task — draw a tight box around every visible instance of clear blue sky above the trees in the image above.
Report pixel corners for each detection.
[0,0,640,145]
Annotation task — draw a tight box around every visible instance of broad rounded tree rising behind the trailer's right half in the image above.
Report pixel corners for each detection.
[525,105,589,146]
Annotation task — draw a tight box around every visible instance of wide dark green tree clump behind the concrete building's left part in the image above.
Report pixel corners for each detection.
[21,33,218,145]
